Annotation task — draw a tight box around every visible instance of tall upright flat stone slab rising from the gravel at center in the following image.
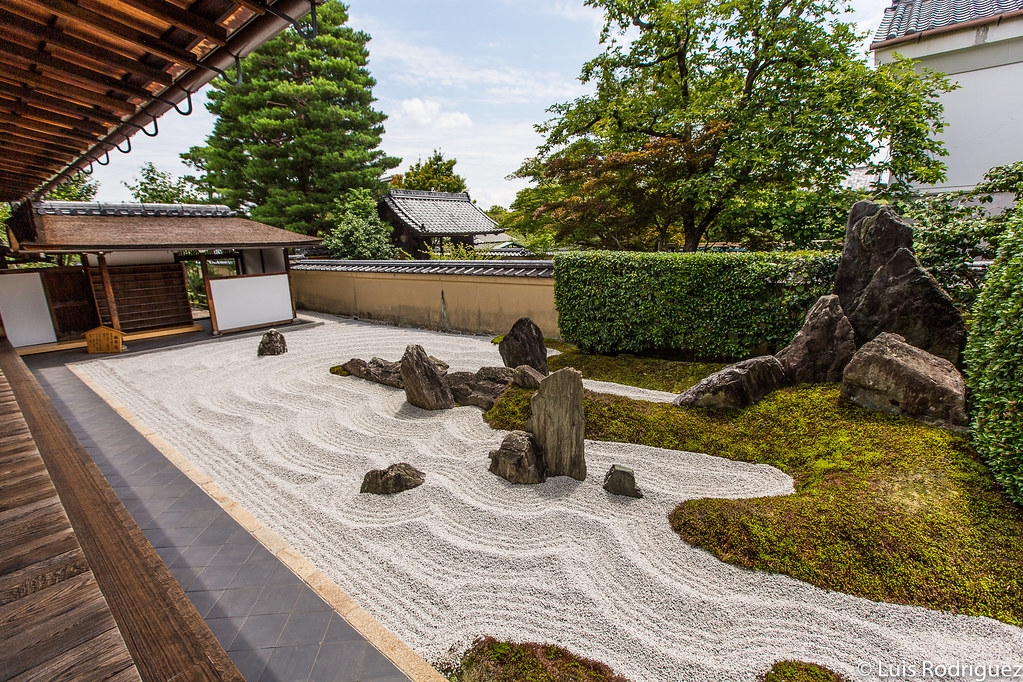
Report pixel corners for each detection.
[526,367,586,481]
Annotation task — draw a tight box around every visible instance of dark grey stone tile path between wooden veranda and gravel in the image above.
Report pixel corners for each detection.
[24,339,408,682]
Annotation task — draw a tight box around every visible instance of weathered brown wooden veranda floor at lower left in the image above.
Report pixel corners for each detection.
[0,336,241,680]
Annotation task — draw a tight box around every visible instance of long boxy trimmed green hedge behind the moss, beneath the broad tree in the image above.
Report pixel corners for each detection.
[554,252,841,361]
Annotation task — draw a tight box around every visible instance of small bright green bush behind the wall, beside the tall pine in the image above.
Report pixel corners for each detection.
[323,187,396,261]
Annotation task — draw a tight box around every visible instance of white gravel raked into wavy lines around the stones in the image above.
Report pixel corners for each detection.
[77,316,1023,682]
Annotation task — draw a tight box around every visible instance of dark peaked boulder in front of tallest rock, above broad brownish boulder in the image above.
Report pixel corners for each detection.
[849,248,966,365]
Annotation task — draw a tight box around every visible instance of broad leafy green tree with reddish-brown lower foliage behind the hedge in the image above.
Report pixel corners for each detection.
[527,0,950,251]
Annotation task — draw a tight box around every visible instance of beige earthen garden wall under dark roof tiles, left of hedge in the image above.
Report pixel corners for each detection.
[292,270,559,338]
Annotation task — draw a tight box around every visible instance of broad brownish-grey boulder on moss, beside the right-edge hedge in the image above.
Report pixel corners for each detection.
[842,333,968,433]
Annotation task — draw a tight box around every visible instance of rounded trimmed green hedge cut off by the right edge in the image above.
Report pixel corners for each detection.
[965,218,1023,504]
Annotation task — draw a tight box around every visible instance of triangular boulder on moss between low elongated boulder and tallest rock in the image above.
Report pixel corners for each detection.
[774,294,856,383]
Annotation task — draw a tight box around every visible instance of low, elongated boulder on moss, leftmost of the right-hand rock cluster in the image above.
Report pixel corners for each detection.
[674,355,790,410]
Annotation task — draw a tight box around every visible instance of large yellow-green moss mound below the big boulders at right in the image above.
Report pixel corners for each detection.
[484,384,1023,625]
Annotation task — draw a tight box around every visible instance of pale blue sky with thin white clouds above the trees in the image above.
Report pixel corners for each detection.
[85,0,889,208]
